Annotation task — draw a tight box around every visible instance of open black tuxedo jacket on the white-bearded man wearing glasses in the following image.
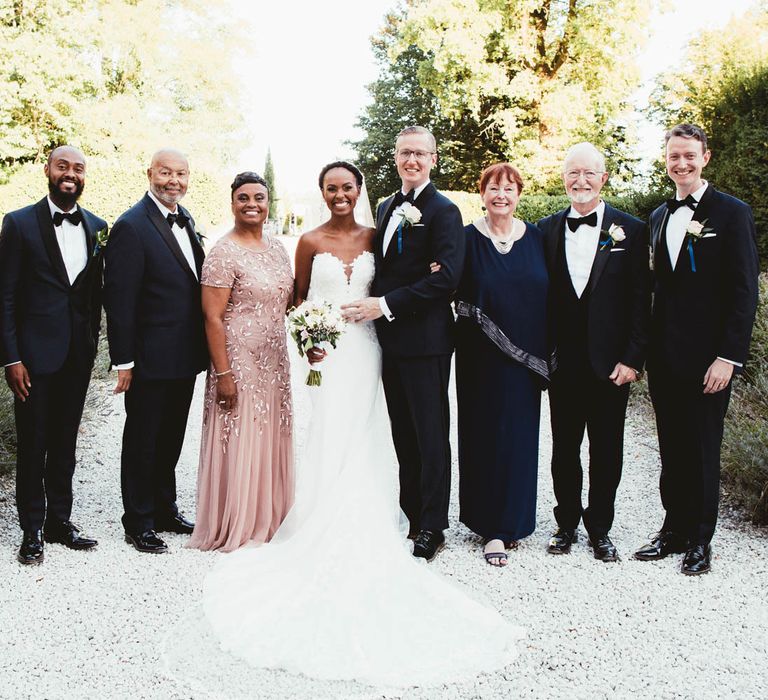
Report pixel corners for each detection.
[537,203,651,379]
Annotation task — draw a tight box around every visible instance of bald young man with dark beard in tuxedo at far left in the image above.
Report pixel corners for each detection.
[0,146,107,564]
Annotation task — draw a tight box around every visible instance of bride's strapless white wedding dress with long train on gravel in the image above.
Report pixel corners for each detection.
[165,253,522,688]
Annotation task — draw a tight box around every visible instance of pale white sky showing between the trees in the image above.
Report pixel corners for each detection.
[233,0,755,194]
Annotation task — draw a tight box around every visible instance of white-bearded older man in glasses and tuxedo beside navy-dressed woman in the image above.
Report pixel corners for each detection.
[538,143,651,561]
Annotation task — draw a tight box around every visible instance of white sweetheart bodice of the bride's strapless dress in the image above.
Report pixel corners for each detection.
[307,250,375,306]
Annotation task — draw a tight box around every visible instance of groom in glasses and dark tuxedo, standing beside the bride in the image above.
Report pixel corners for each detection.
[343,126,464,560]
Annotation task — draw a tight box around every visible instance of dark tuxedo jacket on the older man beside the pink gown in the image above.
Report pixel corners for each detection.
[104,194,208,379]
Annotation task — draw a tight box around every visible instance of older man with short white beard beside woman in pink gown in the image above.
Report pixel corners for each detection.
[104,149,208,552]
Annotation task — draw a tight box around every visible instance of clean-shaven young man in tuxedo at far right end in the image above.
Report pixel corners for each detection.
[635,124,759,575]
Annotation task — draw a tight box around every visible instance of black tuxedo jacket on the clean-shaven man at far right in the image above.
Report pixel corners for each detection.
[649,180,759,380]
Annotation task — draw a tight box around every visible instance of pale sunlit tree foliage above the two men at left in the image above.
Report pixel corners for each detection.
[0,0,246,227]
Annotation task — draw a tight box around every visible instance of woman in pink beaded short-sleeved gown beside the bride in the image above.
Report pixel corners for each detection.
[188,172,294,552]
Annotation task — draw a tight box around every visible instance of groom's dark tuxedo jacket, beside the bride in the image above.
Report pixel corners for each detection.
[371,182,464,357]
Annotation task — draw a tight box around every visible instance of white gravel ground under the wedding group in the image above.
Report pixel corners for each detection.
[0,366,768,699]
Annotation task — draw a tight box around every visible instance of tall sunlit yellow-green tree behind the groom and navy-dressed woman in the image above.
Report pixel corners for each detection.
[352,0,653,193]
